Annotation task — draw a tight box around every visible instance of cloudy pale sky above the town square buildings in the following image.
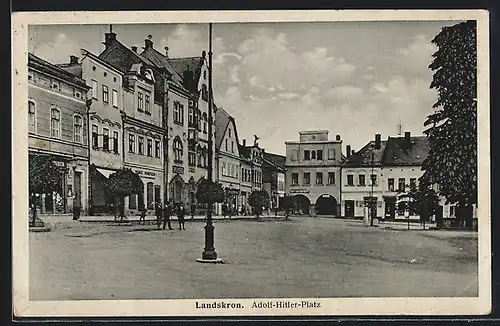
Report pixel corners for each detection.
[28,21,456,154]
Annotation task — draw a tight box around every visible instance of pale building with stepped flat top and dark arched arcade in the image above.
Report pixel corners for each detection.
[285,130,343,216]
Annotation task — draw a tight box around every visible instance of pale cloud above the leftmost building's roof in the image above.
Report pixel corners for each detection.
[32,33,81,63]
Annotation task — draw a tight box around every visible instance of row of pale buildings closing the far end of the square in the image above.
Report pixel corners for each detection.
[285,130,468,220]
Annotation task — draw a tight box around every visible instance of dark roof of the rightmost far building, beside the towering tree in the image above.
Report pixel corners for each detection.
[384,136,429,166]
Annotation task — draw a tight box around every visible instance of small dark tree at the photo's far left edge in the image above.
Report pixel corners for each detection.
[28,155,63,226]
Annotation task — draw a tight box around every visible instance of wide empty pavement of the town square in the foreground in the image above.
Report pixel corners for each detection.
[29,217,478,300]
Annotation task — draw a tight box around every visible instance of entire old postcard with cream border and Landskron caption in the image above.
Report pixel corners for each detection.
[9,11,491,316]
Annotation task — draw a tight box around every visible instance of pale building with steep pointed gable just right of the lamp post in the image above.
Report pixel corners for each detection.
[215,108,241,215]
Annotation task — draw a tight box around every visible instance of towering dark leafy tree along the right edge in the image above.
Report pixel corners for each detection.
[420,21,477,228]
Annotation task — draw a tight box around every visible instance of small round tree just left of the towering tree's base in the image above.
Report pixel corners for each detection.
[399,183,439,228]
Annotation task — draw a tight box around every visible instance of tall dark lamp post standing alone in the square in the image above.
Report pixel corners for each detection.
[196,23,222,263]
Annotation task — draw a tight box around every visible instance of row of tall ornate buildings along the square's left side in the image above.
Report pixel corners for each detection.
[28,31,285,214]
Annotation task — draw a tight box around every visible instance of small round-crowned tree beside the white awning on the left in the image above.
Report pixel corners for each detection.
[103,168,144,221]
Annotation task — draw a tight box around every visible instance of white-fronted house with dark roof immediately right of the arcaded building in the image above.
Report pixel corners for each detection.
[341,134,387,218]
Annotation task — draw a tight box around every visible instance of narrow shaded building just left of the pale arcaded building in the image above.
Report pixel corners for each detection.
[262,152,286,210]
